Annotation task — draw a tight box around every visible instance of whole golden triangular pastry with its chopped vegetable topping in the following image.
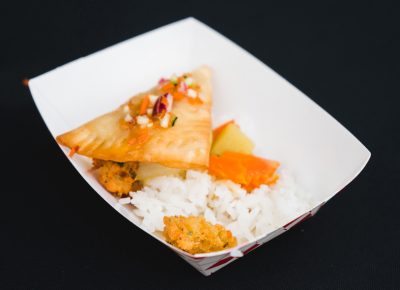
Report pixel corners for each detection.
[57,67,211,169]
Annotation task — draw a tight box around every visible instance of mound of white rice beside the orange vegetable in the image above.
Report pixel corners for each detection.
[124,170,311,243]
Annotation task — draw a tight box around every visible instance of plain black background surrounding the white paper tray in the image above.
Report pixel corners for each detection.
[0,1,400,289]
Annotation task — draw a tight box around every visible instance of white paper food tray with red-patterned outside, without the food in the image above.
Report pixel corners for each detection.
[29,18,371,275]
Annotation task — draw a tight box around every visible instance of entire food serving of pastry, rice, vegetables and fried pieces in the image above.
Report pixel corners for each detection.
[56,66,307,254]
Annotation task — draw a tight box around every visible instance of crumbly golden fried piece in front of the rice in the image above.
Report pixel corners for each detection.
[164,216,237,254]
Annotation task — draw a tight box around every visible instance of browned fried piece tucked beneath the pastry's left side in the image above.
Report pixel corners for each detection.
[93,159,140,197]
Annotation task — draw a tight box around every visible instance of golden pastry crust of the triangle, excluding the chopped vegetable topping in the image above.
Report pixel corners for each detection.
[56,67,211,169]
